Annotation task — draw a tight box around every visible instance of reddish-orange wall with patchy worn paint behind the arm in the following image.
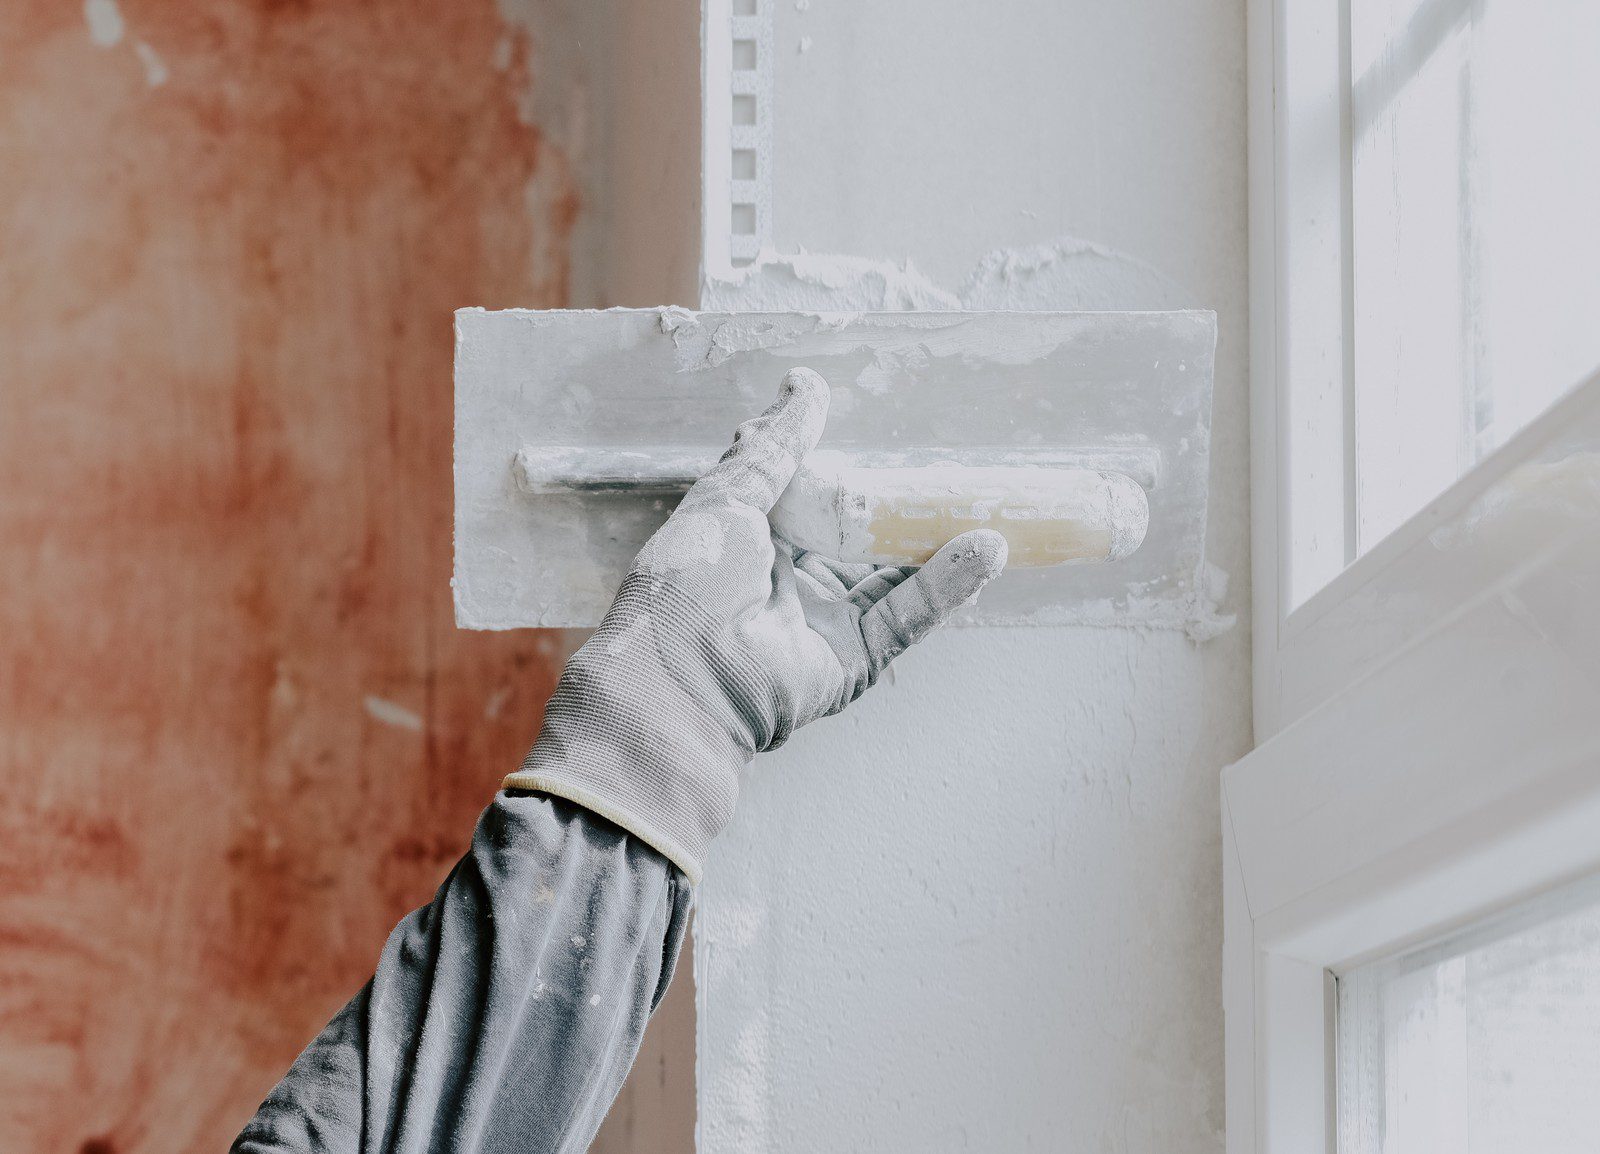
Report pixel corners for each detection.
[0,0,600,1154]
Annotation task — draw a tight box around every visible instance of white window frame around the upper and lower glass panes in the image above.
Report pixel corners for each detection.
[1241,0,1600,1154]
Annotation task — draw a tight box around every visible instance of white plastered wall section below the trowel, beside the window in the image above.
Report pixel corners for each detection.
[698,627,1237,1152]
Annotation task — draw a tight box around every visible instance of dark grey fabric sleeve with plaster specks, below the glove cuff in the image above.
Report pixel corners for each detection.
[234,792,691,1154]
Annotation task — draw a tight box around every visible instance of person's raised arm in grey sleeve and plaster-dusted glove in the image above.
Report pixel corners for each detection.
[235,370,1006,1154]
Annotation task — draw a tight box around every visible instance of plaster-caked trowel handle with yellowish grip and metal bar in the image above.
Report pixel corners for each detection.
[514,447,1150,567]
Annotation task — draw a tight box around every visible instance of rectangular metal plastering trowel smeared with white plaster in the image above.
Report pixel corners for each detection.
[454,309,1216,627]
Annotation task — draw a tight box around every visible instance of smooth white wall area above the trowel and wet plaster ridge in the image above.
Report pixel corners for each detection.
[773,0,1245,300]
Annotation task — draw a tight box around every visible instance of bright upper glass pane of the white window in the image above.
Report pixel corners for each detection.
[1349,0,1600,552]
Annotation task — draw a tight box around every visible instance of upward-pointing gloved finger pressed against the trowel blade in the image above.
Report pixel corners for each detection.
[690,368,829,515]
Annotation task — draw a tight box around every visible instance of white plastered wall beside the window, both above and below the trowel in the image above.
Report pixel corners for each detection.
[696,0,1250,1154]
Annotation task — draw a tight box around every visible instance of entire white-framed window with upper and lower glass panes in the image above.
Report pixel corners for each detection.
[1222,0,1600,1154]
